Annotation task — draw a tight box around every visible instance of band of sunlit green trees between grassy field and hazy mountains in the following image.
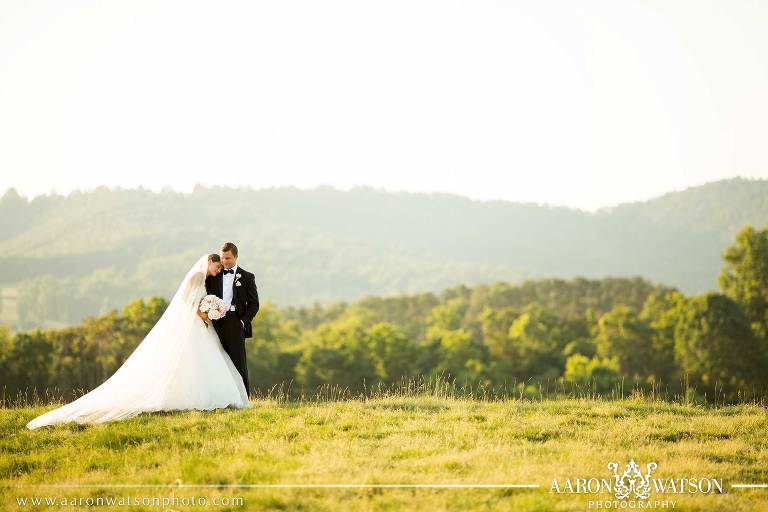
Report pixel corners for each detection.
[0,225,768,401]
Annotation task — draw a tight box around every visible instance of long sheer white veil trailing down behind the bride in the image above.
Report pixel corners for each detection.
[27,254,218,429]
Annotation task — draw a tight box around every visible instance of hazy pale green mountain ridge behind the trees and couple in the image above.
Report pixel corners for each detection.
[0,178,768,325]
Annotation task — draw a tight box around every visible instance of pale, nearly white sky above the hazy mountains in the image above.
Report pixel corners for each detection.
[0,0,768,210]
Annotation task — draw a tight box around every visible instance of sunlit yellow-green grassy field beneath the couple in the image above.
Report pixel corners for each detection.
[0,386,768,512]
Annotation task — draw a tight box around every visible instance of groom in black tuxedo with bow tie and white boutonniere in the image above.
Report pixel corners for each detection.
[205,242,259,394]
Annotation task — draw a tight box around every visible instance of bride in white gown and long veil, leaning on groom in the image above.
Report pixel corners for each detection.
[27,254,251,429]
